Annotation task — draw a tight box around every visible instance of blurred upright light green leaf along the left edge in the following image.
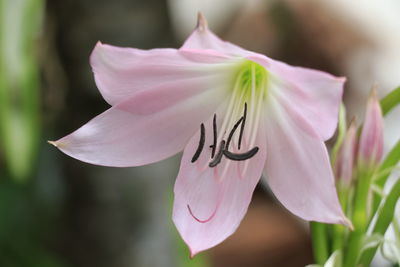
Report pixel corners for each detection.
[0,0,44,182]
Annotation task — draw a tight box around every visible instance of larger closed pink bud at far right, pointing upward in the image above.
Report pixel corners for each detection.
[358,88,383,166]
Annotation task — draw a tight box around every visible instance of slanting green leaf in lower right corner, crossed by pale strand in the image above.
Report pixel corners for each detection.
[360,178,400,266]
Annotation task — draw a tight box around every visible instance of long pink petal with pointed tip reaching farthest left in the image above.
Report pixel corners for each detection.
[53,79,226,167]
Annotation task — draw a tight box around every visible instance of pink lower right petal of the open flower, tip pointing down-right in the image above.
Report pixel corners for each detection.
[264,97,351,225]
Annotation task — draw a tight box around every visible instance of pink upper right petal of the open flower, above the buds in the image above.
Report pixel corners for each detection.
[247,54,346,141]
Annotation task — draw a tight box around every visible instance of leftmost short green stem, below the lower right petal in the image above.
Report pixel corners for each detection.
[310,222,329,265]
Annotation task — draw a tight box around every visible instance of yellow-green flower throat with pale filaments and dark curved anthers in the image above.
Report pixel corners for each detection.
[192,60,268,169]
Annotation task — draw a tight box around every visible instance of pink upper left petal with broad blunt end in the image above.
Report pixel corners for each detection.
[90,42,234,105]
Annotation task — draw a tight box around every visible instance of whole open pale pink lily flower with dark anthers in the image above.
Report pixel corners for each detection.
[52,15,351,256]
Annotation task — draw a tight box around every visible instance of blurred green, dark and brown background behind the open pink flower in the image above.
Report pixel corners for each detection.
[0,0,400,267]
